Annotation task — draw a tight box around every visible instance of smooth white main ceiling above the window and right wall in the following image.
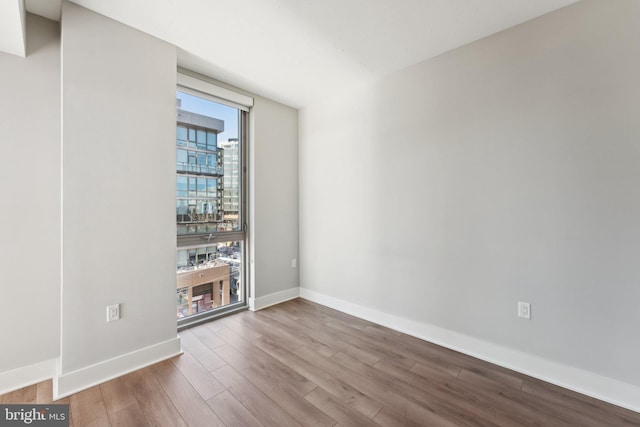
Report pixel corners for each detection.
[27,0,578,107]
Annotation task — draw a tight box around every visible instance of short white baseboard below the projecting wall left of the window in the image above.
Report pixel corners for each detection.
[53,336,182,400]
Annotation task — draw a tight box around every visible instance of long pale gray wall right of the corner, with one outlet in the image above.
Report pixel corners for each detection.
[299,0,640,385]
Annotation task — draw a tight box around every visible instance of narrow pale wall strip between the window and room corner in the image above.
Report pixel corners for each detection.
[251,97,300,298]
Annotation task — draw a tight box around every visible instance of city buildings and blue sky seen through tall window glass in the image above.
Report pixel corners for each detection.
[176,91,244,319]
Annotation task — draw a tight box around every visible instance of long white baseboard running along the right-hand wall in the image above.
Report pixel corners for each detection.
[300,287,640,412]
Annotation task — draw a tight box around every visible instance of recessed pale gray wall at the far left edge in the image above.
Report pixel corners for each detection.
[0,14,60,374]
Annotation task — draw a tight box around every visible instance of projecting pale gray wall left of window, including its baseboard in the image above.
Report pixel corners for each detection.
[60,2,179,393]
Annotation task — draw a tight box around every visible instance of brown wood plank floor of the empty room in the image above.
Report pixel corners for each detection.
[0,299,640,427]
